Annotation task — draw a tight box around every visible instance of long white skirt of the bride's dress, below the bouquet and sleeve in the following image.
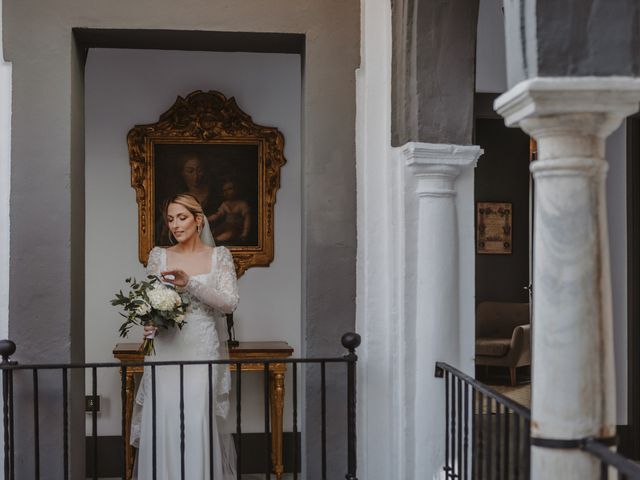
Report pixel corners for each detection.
[131,315,236,480]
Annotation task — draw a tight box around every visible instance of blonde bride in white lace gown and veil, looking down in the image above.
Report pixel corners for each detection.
[131,194,238,480]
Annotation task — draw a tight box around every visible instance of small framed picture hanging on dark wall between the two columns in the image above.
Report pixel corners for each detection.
[476,202,513,254]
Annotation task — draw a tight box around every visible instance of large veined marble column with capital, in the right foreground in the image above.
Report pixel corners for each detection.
[495,77,640,480]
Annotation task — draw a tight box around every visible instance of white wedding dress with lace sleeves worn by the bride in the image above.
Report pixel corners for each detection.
[131,247,238,480]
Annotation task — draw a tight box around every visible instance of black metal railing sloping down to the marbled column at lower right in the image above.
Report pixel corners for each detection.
[436,362,640,480]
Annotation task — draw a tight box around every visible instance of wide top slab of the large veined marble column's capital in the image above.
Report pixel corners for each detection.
[493,77,640,136]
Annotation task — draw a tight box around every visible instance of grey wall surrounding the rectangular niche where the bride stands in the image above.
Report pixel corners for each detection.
[3,0,360,478]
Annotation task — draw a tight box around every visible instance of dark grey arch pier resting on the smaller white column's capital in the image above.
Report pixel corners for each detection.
[391,0,478,146]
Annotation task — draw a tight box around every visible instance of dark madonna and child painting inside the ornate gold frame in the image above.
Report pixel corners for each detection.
[154,144,260,247]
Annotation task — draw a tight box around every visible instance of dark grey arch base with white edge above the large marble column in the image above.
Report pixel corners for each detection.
[504,0,640,87]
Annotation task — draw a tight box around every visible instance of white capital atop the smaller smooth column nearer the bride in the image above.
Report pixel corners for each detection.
[400,142,483,197]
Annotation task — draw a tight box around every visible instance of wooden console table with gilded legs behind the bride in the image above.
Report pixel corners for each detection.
[113,342,293,480]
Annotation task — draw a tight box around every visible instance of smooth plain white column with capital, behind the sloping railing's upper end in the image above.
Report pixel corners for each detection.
[402,143,482,478]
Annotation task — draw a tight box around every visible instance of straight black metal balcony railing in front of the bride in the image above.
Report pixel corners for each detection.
[0,333,360,480]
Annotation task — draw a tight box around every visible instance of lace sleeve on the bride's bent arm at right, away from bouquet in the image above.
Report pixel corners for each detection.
[187,247,238,313]
